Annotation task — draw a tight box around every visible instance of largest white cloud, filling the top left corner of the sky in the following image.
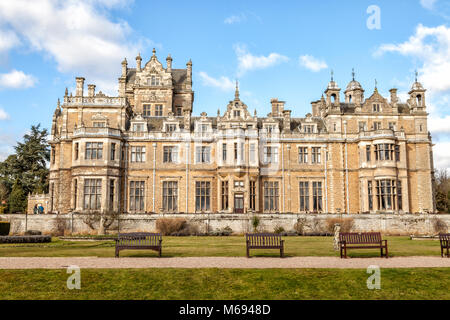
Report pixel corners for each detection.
[0,0,148,94]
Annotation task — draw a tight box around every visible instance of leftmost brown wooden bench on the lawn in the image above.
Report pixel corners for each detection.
[116,232,162,258]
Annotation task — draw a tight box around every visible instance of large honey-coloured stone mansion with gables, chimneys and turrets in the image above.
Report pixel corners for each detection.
[40,50,435,214]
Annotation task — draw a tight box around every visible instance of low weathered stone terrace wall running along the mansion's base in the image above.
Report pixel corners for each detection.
[0,214,450,235]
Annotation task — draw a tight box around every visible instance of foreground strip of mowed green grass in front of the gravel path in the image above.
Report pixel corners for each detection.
[0,268,450,300]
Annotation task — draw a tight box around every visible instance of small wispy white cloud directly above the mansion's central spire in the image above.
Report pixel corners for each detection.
[234,45,289,75]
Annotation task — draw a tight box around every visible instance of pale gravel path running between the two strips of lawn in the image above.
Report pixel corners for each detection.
[0,257,450,269]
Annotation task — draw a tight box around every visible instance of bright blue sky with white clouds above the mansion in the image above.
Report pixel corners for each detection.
[0,0,450,168]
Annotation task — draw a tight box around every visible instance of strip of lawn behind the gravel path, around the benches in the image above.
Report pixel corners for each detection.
[0,236,440,257]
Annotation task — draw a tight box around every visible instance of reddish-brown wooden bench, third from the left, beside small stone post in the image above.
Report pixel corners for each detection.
[339,232,388,258]
